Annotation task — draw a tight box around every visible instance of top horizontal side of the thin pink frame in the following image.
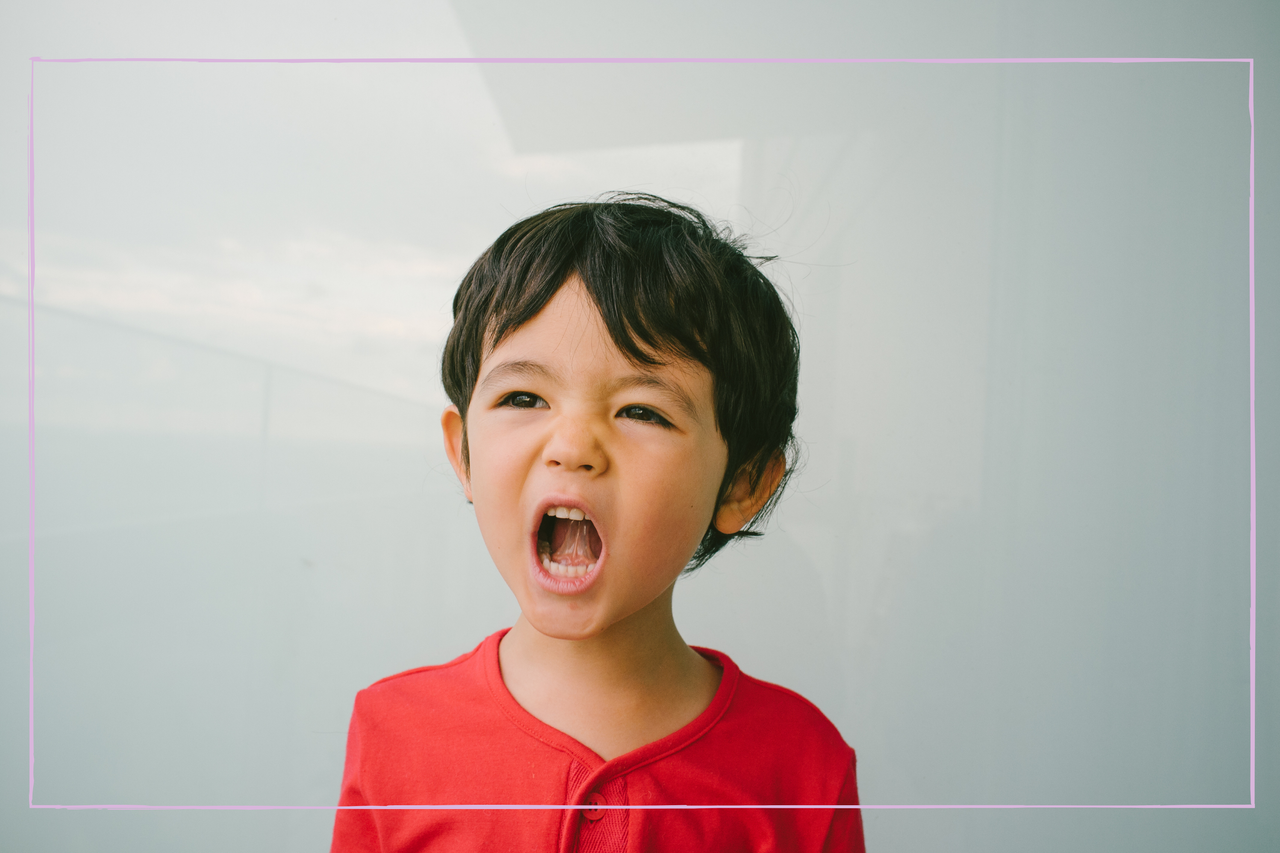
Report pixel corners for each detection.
[32,56,1253,65]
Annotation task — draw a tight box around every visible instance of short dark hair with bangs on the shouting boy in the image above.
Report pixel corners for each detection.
[440,193,800,571]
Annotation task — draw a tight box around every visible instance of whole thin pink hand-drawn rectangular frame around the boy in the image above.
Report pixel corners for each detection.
[27,56,1258,811]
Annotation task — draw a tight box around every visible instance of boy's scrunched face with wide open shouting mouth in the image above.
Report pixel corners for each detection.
[442,279,741,639]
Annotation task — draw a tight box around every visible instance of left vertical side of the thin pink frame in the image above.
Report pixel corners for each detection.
[27,60,36,807]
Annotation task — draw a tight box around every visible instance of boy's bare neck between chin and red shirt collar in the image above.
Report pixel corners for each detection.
[498,589,721,760]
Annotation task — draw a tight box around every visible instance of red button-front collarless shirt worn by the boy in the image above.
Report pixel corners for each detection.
[332,631,864,853]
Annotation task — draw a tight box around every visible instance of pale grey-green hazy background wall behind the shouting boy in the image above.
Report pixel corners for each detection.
[0,1,1280,850]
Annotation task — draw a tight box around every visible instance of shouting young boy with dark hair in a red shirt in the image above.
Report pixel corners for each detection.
[333,195,863,853]
